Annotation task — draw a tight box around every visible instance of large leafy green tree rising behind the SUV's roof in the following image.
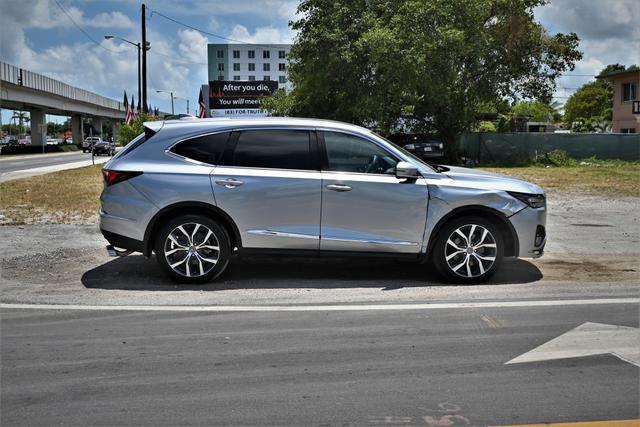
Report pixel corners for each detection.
[265,0,582,157]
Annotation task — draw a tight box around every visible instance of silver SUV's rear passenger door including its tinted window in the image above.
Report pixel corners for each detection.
[211,128,322,250]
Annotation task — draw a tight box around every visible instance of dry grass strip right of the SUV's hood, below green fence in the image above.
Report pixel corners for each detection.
[481,158,640,197]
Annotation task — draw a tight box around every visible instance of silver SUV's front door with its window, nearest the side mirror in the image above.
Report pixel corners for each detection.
[320,131,428,254]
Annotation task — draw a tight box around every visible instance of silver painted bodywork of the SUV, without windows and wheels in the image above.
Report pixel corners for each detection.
[100,118,546,257]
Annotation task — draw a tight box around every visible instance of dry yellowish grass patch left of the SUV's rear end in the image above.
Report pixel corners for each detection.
[0,165,102,225]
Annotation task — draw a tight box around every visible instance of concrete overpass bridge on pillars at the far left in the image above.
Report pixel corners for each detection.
[0,62,125,145]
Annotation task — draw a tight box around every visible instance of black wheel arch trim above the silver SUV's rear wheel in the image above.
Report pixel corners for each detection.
[143,202,242,257]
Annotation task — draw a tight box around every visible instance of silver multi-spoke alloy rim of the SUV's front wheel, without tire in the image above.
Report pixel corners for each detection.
[444,224,498,279]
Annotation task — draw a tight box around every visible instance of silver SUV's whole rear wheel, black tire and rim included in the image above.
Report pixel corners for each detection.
[154,215,231,283]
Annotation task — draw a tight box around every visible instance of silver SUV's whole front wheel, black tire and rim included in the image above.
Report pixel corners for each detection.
[432,216,504,283]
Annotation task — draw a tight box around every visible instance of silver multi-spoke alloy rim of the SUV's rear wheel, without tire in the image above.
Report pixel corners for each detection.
[164,222,220,277]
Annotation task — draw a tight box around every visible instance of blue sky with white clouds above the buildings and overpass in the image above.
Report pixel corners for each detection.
[0,0,640,123]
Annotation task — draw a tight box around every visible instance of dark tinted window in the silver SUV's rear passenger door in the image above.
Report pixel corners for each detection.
[231,129,315,170]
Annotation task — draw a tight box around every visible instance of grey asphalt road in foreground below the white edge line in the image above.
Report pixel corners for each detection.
[0,302,640,426]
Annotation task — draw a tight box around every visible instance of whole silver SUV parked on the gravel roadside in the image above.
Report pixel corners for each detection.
[100,118,546,282]
